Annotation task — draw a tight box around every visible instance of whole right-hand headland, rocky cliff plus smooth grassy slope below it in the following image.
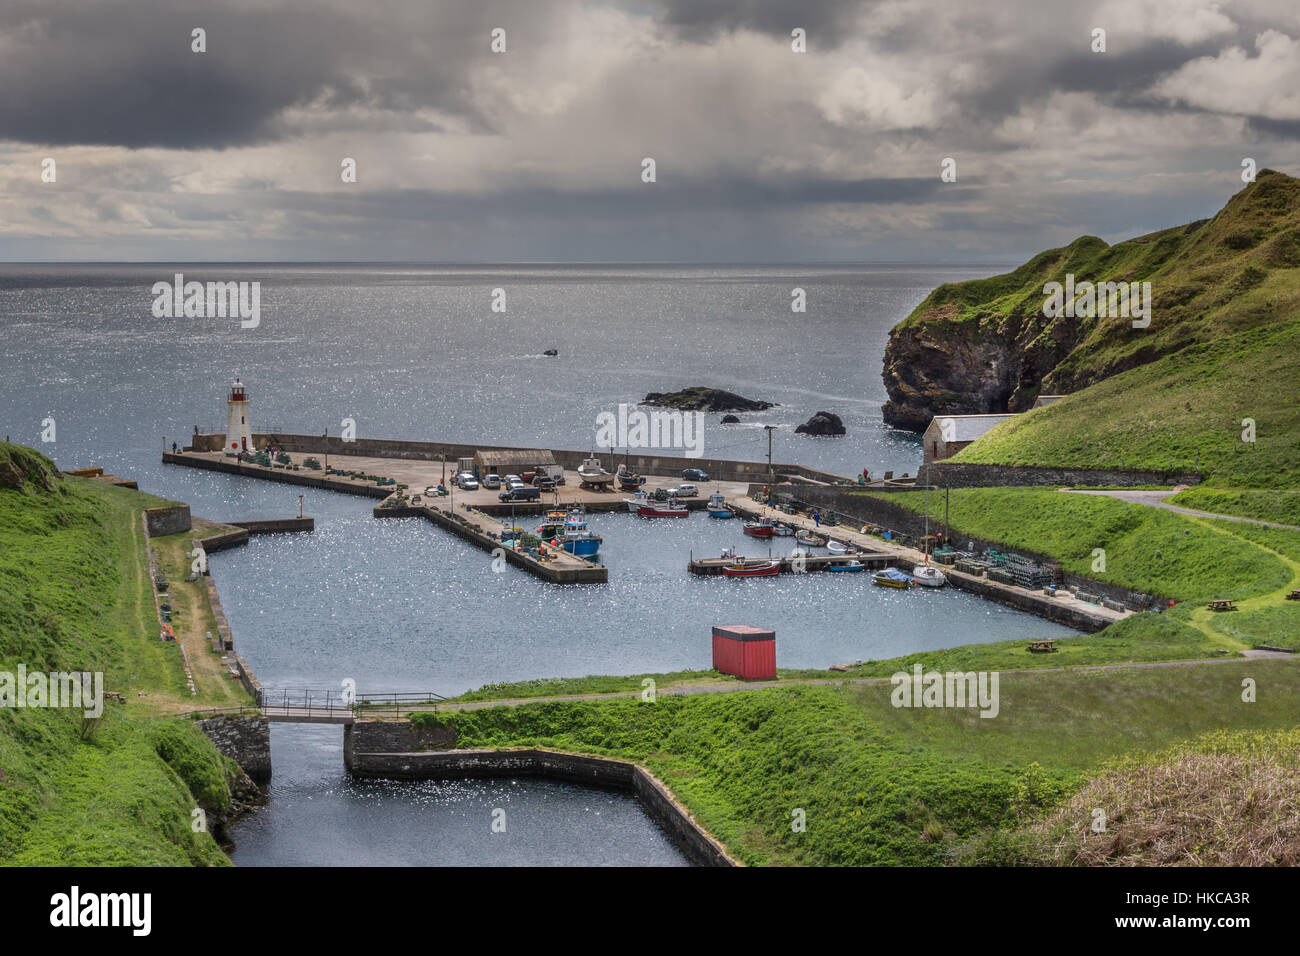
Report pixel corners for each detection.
[884,170,1300,486]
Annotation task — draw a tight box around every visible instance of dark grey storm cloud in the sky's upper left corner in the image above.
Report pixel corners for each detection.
[0,0,546,148]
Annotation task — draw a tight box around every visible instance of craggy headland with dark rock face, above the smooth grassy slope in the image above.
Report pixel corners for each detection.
[883,170,1300,432]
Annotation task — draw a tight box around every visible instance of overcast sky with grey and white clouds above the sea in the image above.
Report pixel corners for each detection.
[0,0,1300,261]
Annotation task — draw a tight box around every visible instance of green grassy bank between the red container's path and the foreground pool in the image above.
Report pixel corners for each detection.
[412,661,1300,865]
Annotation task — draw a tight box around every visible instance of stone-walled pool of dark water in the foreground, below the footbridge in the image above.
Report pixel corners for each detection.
[231,723,690,866]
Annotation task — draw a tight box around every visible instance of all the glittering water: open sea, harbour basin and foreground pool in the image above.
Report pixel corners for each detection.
[0,265,1067,864]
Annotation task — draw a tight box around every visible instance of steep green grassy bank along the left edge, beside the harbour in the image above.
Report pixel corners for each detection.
[0,444,246,865]
